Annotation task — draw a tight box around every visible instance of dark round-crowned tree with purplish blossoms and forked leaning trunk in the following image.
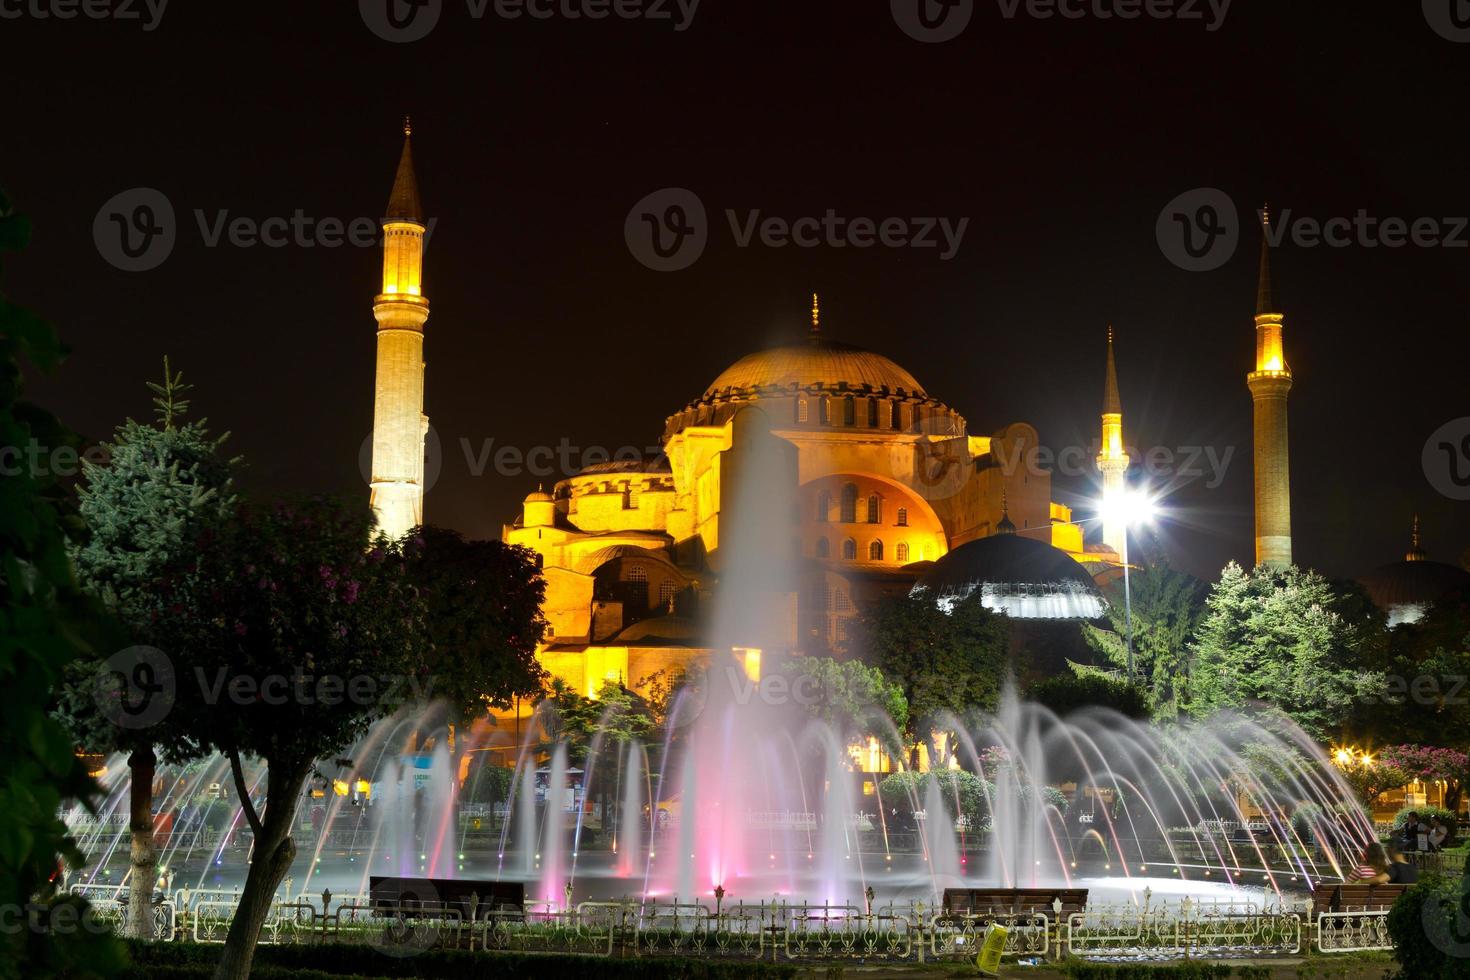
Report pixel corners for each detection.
[154,500,426,979]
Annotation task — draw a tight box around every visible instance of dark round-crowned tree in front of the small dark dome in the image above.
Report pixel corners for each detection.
[854,591,1010,765]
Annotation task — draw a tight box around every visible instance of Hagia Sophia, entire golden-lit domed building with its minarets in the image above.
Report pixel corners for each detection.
[358,123,1470,719]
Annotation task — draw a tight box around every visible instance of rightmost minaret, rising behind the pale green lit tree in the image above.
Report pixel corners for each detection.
[1245,209,1291,569]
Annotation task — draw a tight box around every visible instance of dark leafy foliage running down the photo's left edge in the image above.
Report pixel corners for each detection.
[0,194,122,980]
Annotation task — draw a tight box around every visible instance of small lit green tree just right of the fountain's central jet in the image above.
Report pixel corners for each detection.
[781,657,908,751]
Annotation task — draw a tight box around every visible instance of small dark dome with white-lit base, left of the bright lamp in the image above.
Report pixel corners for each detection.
[914,533,1104,619]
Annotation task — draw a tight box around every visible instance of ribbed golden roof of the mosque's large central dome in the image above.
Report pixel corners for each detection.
[704,339,925,398]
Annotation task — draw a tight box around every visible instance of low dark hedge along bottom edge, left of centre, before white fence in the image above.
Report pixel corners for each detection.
[125,940,797,980]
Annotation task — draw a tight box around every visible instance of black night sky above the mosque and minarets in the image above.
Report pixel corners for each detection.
[0,0,1470,576]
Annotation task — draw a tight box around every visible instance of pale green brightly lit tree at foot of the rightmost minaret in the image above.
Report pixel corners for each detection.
[1189,561,1383,739]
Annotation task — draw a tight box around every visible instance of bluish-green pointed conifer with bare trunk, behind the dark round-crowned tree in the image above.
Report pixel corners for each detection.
[59,357,235,939]
